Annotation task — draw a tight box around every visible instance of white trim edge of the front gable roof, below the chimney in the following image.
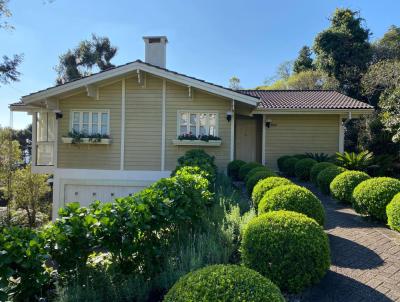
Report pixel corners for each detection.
[21,60,259,106]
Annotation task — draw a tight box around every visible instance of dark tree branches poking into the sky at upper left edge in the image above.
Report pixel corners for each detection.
[0,0,23,84]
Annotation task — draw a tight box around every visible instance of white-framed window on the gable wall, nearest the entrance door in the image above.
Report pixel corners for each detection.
[178,111,218,136]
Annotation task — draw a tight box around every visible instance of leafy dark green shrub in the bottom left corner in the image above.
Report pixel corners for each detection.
[0,227,50,301]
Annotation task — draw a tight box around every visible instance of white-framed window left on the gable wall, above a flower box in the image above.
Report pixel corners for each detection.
[71,110,110,135]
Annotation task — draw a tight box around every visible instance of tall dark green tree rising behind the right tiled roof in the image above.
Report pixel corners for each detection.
[313,9,371,98]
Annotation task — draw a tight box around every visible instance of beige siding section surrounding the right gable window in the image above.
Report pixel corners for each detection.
[165,82,231,171]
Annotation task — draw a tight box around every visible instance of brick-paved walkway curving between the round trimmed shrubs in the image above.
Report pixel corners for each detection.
[299,183,400,302]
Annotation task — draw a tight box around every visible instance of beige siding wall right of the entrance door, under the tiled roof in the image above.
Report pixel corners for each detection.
[265,114,339,169]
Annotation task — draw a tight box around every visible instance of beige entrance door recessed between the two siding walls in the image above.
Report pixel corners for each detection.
[235,118,258,162]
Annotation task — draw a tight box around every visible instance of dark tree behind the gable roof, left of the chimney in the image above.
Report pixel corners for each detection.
[55,34,117,84]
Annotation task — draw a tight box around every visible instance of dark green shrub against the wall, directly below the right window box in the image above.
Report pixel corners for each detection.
[172,149,218,183]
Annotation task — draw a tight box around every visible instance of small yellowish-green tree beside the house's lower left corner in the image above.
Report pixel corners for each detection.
[12,166,50,227]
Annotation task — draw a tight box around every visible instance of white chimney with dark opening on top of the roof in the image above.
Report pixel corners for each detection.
[143,36,168,68]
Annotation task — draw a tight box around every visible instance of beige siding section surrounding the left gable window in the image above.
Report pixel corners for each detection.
[58,82,122,170]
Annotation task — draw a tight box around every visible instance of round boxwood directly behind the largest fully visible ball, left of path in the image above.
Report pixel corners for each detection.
[258,184,325,225]
